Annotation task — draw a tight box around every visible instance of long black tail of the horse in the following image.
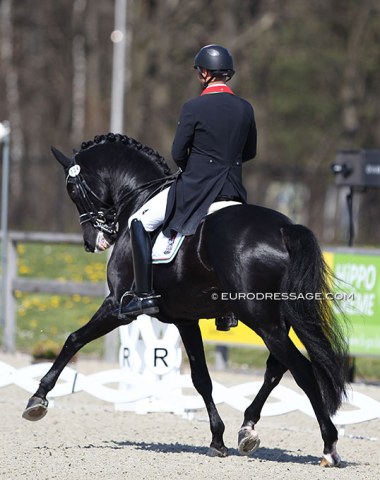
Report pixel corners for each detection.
[281,225,348,415]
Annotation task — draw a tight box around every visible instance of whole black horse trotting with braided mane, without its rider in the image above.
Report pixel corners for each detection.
[23,134,347,466]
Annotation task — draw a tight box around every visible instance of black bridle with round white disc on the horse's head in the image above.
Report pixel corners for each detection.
[66,163,118,240]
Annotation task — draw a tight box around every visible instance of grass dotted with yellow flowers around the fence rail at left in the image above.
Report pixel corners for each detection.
[8,243,107,356]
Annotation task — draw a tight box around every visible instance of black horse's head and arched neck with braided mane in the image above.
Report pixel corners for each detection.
[52,133,175,252]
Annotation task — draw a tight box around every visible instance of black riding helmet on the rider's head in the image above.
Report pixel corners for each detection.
[194,44,235,80]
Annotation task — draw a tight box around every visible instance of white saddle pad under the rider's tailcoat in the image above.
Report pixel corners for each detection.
[152,200,241,263]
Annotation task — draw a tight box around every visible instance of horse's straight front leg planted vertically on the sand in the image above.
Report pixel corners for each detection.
[177,323,228,457]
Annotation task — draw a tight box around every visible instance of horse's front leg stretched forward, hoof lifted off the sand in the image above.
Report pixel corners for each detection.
[22,297,122,421]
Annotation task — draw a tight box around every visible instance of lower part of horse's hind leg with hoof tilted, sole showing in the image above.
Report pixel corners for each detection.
[238,354,287,455]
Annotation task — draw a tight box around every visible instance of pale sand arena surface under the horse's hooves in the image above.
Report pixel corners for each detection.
[0,354,380,480]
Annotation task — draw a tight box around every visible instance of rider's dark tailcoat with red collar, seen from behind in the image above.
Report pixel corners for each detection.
[163,87,257,237]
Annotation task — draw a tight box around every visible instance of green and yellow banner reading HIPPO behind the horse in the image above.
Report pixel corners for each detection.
[200,249,380,355]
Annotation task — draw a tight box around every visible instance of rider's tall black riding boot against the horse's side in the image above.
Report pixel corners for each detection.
[119,219,160,317]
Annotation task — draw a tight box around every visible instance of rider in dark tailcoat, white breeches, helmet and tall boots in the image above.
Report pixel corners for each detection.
[121,45,257,326]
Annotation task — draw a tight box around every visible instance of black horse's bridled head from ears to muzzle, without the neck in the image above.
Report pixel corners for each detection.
[51,147,117,252]
